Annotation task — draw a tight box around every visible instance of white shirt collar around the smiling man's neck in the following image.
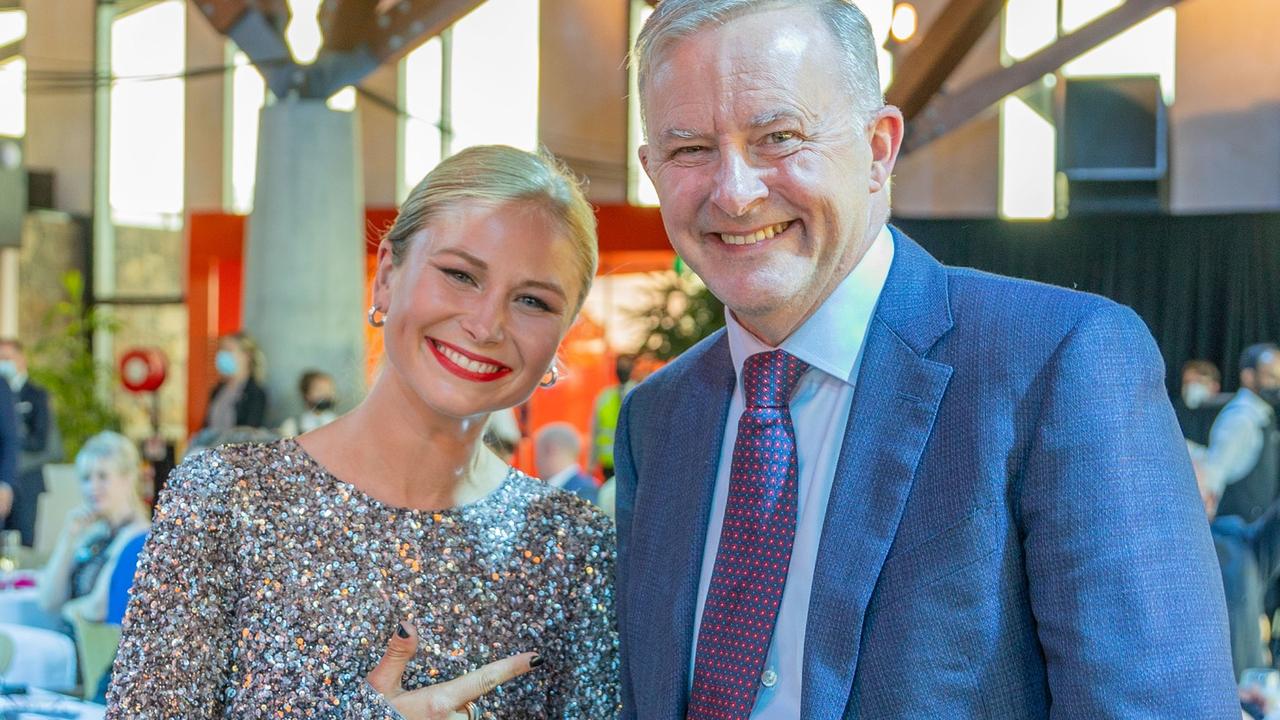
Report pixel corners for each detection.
[724,225,893,384]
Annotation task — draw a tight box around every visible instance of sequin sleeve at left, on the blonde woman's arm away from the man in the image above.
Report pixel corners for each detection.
[106,452,237,720]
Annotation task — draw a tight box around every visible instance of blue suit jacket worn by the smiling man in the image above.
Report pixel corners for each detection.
[616,231,1240,720]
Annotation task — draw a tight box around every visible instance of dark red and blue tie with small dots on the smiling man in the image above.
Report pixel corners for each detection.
[687,350,809,720]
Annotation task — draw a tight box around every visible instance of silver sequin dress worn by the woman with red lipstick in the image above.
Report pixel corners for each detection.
[106,439,618,720]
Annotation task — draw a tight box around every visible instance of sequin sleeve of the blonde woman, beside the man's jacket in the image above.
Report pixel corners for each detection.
[549,509,621,720]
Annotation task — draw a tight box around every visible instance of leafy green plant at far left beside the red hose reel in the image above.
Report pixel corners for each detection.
[28,270,120,460]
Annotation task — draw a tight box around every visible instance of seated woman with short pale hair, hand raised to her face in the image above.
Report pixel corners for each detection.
[38,432,151,621]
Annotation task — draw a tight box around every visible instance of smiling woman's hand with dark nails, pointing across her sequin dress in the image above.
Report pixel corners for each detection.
[366,623,543,720]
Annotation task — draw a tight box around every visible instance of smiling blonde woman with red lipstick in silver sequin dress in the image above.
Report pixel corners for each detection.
[108,146,618,720]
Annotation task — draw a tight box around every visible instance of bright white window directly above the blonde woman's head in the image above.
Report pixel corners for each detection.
[399,0,539,197]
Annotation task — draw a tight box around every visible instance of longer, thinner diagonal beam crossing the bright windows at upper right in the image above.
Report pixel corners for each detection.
[902,0,1179,155]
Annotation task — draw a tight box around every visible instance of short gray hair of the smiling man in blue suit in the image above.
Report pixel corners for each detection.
[631,0,884,128]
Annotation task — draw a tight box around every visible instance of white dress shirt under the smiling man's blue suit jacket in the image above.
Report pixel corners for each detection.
[689,227,893,720]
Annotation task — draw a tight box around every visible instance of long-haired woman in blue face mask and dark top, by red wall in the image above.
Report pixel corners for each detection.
[204,332,266,430]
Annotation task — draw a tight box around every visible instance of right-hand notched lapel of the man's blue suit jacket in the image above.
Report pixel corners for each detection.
[801,229,951,720]
